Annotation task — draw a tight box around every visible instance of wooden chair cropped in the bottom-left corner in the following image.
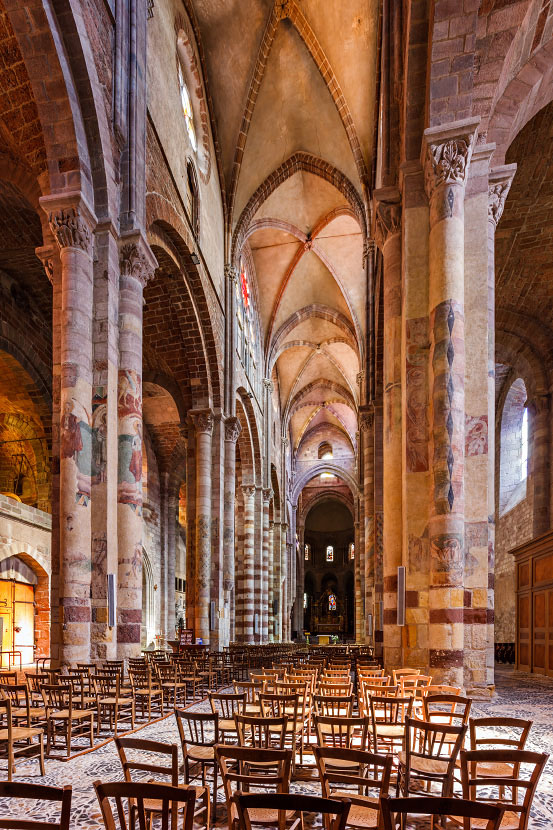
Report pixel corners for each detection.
[0,781,72,830]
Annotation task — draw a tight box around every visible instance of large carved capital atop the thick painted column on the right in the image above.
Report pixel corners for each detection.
[421,118,480,202]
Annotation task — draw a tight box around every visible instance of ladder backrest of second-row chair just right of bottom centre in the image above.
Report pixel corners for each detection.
[313,746,393,798]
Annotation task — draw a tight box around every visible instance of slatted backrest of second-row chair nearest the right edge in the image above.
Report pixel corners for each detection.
[461,749,549,830]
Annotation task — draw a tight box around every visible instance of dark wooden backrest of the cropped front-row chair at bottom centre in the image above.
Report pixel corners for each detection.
[233,793,351,830]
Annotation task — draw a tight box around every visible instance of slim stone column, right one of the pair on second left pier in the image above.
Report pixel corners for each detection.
[223,417,242,642]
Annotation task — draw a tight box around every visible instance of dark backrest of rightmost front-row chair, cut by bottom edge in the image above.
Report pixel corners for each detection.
[380,795,503,830]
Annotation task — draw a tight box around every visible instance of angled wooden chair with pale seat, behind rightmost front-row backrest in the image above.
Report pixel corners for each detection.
[397,717,467,798]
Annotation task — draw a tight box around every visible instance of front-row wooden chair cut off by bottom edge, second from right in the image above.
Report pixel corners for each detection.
[233,793,350,830]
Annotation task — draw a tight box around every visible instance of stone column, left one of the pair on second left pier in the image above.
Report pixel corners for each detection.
[190,409,213,644]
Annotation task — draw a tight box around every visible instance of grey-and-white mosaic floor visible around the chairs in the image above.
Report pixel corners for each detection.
[0,667,553,830]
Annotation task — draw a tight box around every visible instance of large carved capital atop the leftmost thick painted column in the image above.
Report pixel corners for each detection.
[40,193,97,256]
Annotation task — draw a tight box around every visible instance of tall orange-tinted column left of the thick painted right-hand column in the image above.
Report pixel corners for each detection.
[374,187,403,669]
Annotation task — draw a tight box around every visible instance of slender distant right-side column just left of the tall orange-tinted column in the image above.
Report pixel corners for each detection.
[355,405,376,644]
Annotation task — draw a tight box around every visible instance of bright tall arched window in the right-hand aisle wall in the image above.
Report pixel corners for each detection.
[499,378,529,515]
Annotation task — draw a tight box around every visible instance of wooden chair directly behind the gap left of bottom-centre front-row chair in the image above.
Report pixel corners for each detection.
[215,744,292,830]
